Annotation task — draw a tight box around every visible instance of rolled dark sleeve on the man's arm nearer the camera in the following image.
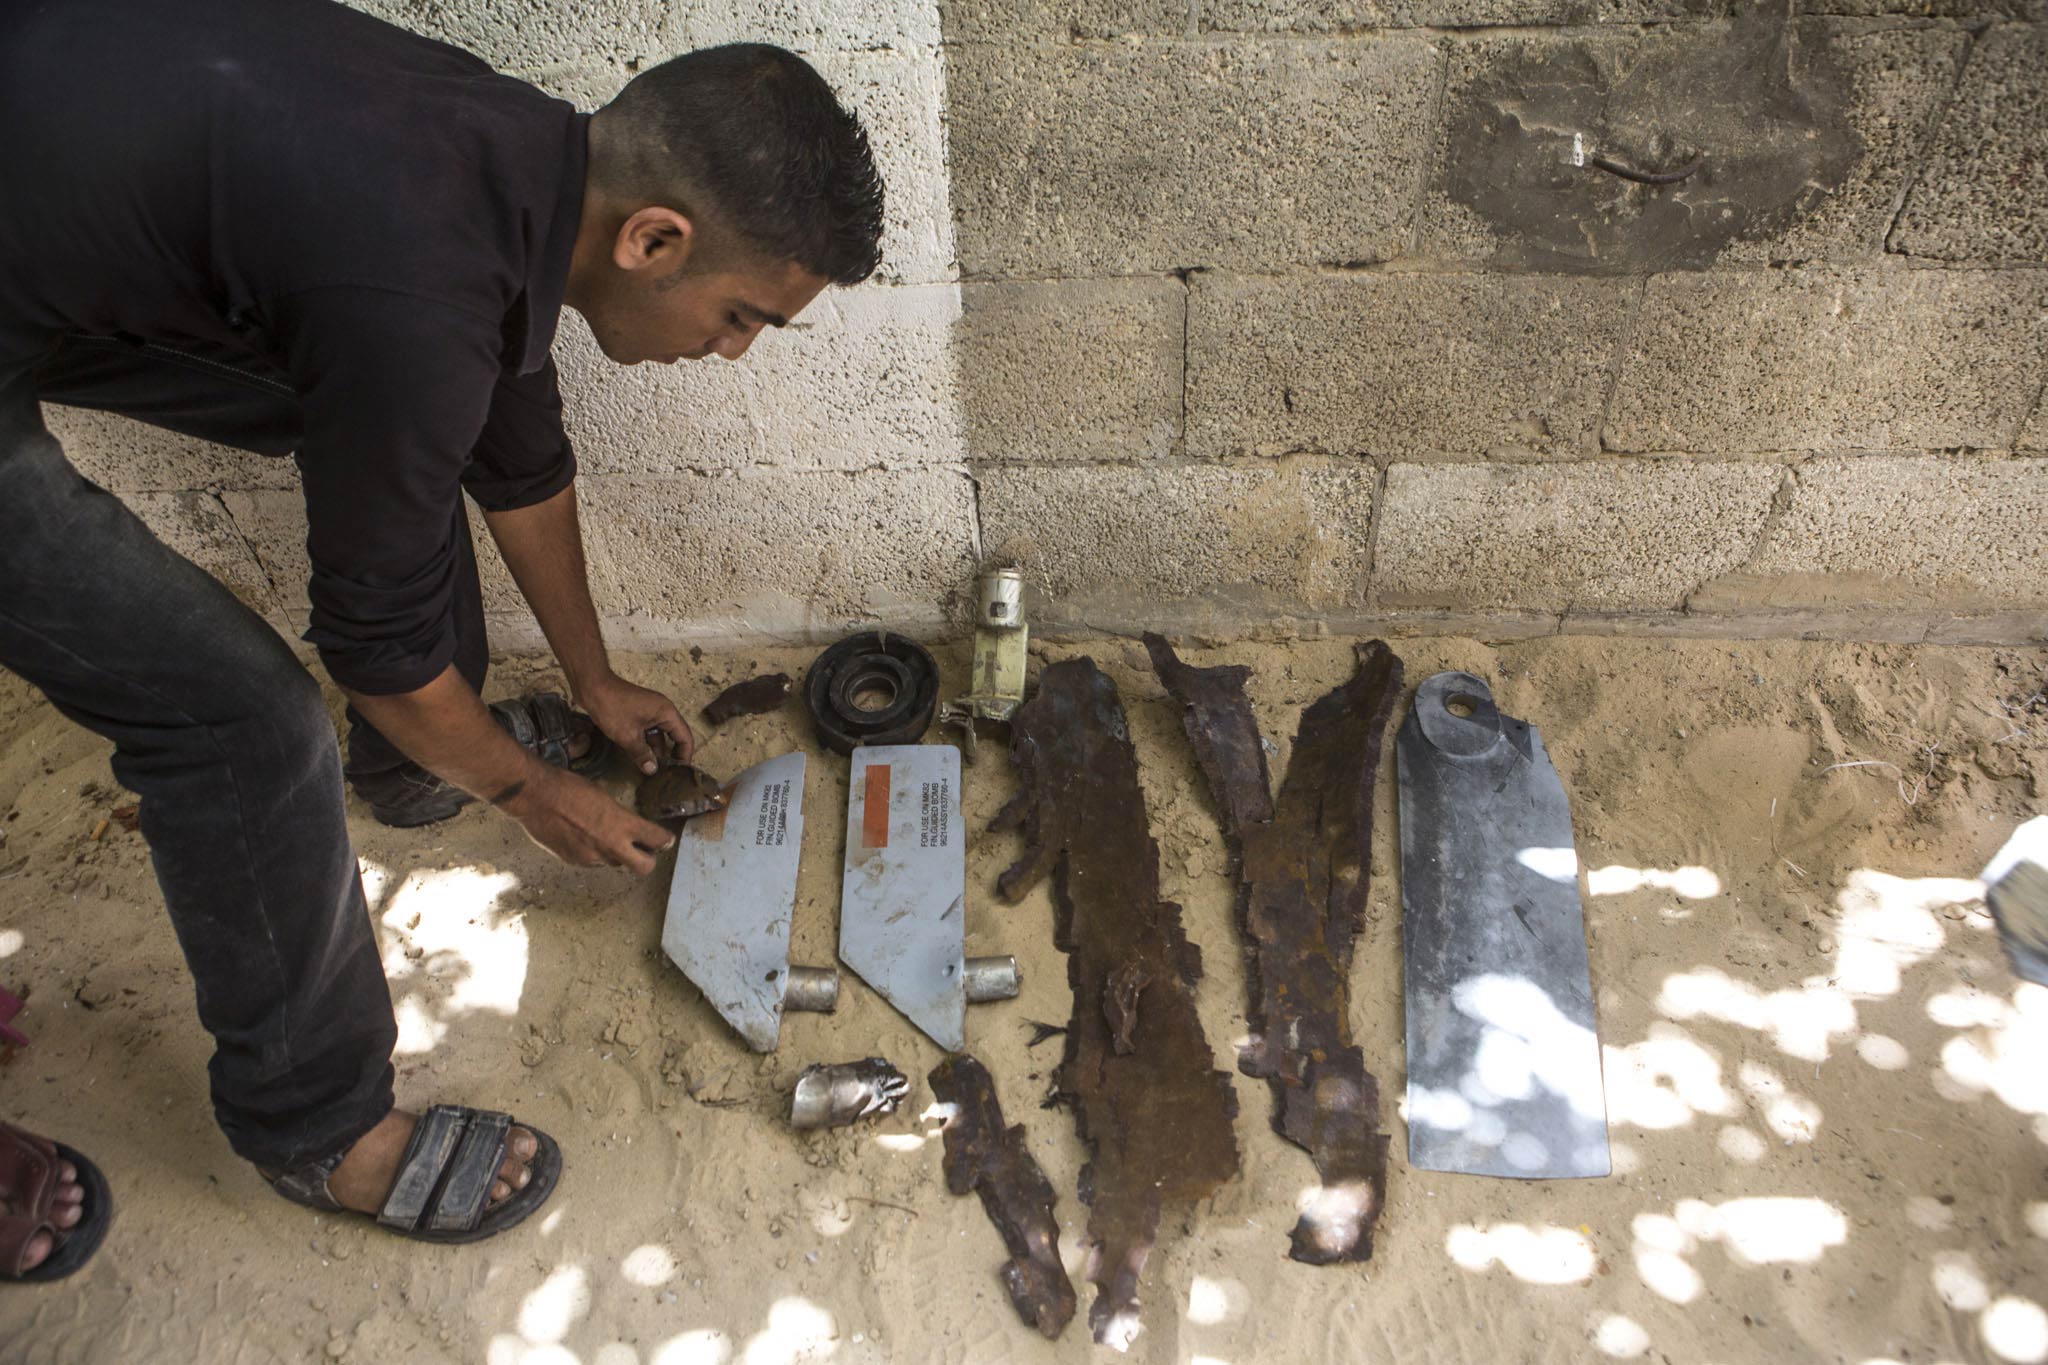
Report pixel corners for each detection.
[281,287,501,696]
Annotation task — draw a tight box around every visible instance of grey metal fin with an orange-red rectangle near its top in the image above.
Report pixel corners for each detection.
[840,745,967,1052]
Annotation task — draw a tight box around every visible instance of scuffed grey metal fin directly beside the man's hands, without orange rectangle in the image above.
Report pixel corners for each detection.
[662,753,805,1052]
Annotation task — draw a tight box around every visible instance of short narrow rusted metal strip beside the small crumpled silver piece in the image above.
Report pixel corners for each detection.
[932,1052,1075,1340]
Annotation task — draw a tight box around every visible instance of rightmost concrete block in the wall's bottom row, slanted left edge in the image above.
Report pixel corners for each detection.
[1702,456,2048,610]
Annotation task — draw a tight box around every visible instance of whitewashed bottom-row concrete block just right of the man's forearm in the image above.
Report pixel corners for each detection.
[582,469,975,639]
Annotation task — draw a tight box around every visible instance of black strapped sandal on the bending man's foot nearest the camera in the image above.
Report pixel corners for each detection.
[262,1105,561,1242]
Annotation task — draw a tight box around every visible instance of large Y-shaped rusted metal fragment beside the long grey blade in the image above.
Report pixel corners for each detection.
[1145,634,1401,1265]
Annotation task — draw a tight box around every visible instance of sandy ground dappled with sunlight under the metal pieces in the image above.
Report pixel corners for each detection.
[0,639,2048,1365]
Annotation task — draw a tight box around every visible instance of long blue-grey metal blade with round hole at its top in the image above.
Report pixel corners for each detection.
[1397,673,1610,1179]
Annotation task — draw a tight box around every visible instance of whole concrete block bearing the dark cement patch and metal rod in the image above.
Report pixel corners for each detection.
[1419,18,1966,272]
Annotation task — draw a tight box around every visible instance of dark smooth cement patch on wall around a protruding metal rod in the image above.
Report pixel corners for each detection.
[1444,12,1864,272]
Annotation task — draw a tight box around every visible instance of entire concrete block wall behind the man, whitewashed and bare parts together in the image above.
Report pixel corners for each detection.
[51,0,2048,649]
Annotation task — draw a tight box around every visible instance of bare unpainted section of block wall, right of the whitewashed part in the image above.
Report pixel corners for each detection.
[942,0,2048,641]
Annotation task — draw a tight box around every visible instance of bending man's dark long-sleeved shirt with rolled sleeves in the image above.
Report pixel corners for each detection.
[0,0,588,694]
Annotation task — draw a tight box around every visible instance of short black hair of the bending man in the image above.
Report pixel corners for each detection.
[596,43,883,284]
